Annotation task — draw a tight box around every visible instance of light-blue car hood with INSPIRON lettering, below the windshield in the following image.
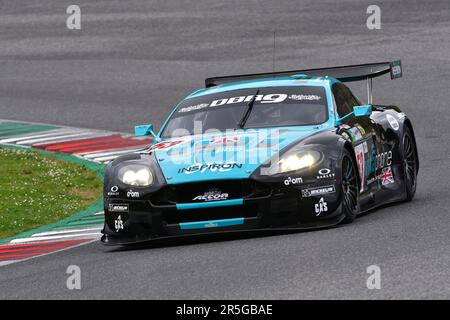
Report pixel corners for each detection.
[151,126,323,184]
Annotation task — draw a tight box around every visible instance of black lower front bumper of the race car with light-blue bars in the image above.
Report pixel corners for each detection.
[102,181,342,245]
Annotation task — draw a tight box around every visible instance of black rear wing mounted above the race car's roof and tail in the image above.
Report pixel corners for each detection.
[205,60,402,103]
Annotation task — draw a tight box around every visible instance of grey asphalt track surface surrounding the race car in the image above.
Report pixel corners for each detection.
[0,0,450,299]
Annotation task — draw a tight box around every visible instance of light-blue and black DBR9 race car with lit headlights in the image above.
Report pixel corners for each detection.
[102,61,419,245]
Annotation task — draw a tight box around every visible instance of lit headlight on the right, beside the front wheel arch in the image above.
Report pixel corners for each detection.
[261,149,322,175]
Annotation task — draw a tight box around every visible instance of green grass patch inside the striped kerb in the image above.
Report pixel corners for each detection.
[0,148,102,239]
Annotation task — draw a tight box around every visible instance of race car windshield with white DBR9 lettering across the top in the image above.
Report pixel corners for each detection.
[162,86,328,138]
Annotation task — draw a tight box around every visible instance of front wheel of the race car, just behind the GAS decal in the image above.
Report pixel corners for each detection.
[342,150,359,223]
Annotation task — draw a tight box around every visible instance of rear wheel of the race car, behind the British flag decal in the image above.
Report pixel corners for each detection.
[402,127,417,201]
